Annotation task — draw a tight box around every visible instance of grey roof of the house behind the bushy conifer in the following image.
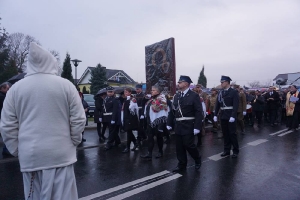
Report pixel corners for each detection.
[78,67,136,84]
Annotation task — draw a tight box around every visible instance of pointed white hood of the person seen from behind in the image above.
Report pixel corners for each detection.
[26,42,58,76]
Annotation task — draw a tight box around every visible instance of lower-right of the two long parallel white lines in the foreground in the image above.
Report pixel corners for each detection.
[108,174,182,200]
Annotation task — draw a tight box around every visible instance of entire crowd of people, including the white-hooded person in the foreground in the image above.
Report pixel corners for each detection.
[0,43,300,200]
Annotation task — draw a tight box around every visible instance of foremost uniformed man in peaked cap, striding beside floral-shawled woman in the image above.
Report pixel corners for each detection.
[167,76,203,172]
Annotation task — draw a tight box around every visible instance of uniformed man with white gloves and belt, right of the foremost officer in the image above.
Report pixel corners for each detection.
[214,76,239,158]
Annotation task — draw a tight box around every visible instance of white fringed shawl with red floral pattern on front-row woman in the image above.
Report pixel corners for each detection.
[144,94,169,127]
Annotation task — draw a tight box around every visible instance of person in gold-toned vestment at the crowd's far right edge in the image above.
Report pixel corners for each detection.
[285,85,300,130]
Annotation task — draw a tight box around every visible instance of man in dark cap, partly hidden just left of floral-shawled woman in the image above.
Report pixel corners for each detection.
[135,84,148,146]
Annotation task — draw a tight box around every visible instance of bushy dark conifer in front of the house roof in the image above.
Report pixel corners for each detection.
[89,63,107,95]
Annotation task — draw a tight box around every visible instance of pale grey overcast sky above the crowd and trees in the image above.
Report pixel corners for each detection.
[0,0,300,87]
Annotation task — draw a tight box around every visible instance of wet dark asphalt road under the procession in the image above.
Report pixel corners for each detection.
[0,126,300,200]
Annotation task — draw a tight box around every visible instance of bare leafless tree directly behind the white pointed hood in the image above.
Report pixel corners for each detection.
[7,33,40,71]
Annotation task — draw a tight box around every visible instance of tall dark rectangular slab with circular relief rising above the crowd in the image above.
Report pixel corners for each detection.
[145,38,176,96]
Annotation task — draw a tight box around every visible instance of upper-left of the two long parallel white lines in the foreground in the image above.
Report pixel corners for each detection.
[79,170,170,200]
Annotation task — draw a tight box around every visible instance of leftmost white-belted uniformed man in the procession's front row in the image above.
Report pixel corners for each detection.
[99,86,121,150]
